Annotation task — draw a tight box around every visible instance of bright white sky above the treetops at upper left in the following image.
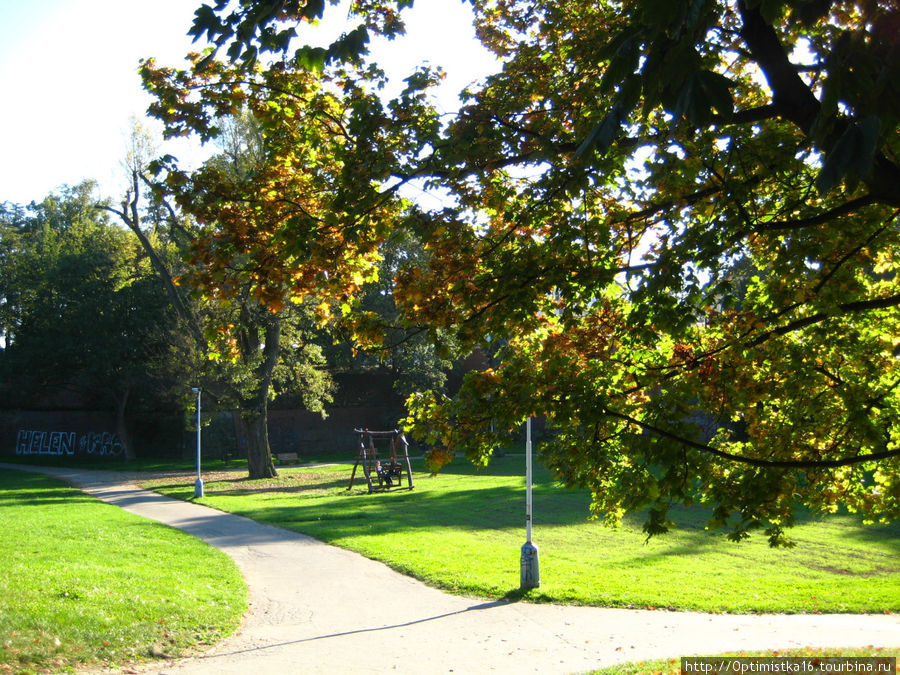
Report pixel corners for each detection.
[0,0,498,204]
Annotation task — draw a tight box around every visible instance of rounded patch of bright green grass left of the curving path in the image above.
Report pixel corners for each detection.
[0,470,247,673]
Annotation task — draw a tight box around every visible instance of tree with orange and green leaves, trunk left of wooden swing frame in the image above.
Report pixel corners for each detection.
[137,51,408,478]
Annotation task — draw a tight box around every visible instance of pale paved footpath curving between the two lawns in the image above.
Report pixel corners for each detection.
[0,465,900,675]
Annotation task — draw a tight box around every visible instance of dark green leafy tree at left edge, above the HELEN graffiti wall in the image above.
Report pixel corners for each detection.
[0,182,178,458]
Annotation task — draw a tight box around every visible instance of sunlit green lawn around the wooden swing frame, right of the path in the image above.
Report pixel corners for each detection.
[148,456,900,613]
